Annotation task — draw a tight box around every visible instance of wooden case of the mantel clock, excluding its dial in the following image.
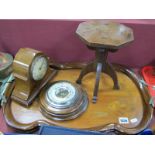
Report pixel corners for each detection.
[11,48,56,106]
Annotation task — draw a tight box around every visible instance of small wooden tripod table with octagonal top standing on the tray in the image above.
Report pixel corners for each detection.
[76,20,134,103]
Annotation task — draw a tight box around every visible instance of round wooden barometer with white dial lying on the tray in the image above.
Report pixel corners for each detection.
[40,81,88,120]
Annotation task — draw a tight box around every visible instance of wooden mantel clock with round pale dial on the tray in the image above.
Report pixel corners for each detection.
[12,48,56,106]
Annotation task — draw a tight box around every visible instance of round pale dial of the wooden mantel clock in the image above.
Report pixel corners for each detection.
[31,56,48,81]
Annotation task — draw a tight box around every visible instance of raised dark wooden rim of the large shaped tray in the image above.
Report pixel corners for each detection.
[3,63,153,134]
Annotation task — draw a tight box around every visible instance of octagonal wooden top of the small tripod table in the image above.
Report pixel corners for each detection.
[76,20,134,49]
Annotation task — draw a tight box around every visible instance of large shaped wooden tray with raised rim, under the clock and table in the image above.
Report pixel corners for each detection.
[3,64,153,134]
